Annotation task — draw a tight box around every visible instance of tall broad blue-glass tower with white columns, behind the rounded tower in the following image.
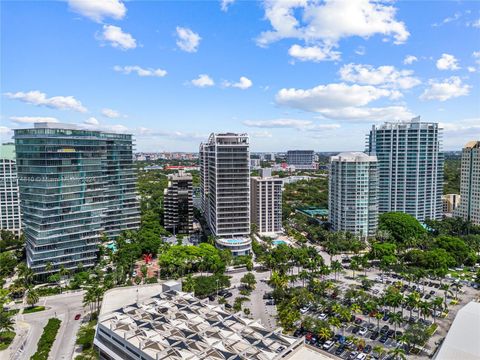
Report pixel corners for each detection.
[367,117,443,221]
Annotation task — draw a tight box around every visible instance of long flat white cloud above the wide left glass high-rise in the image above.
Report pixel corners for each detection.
[4,90,87,112]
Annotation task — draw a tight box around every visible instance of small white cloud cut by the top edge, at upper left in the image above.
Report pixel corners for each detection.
[68,0,127,22]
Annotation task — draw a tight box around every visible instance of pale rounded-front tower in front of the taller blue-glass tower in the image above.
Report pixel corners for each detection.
[328,152,378,239]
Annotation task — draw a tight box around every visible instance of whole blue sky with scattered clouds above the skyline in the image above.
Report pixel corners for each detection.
[0,0,480,151]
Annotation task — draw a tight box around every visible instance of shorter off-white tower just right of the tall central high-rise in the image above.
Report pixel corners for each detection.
[251,169,283,234]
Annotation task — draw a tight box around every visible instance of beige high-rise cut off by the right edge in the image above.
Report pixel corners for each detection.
[455,140,480,225]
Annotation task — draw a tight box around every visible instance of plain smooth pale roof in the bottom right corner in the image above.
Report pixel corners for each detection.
[435,301,480,360]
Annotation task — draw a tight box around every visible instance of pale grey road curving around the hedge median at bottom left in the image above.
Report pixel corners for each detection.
[0,291,84,360]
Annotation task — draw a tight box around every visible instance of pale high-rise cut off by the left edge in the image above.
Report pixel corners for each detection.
[0,144,22,235]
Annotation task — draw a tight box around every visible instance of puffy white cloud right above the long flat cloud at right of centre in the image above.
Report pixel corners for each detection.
[340,64,421,89]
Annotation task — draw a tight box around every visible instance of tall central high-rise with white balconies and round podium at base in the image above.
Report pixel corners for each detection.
[200,133,250,252]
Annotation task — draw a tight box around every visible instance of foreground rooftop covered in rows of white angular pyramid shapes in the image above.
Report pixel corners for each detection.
[99,290,304,360]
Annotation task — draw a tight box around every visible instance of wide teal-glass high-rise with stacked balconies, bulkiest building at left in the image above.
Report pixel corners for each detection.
[14,123,140,274]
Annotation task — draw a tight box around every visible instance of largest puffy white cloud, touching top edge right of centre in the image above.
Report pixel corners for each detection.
[257,0,410,61]
